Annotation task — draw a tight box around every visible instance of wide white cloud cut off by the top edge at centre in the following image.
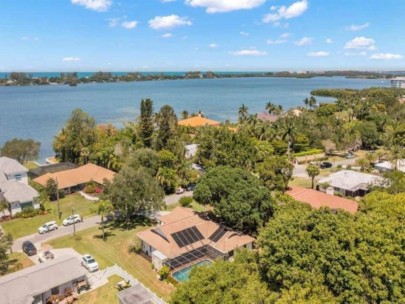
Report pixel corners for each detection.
[186,0,266,14]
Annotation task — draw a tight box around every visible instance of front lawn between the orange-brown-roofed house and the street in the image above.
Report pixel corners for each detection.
[1,193,97,239]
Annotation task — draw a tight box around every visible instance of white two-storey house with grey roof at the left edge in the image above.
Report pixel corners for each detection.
[0,156,40,215]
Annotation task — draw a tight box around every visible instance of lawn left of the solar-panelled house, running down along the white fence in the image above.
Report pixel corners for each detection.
[50,222,174,300]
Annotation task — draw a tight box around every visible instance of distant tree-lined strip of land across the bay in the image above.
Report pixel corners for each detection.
[0,71,401,87]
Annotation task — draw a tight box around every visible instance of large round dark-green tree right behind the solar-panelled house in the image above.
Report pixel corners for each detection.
[193,167,273,232]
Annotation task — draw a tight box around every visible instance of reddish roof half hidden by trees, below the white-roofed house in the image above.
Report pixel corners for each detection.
[286,187,359,213]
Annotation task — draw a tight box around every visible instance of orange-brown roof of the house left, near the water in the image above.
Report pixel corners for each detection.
[34,163,115,189]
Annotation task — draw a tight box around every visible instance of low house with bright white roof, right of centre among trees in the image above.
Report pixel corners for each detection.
[317,170,385,197]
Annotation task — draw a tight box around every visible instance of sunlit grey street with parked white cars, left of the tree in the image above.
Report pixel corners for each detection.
[13,216,100,251]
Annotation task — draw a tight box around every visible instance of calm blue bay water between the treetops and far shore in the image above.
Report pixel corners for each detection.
[0,77,390,161]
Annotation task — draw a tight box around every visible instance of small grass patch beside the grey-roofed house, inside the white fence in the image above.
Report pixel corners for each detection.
[75,275,122,304]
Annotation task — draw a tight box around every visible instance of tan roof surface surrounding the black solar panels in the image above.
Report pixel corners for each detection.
[137,207,255,259]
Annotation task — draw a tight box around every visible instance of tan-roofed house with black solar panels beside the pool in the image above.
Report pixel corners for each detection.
[137,207,255,270]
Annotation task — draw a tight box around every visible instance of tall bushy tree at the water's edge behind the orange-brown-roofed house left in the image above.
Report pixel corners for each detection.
[53,109,97,164]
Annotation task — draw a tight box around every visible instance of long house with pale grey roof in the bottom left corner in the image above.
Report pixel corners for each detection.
[0,256,87,304]
